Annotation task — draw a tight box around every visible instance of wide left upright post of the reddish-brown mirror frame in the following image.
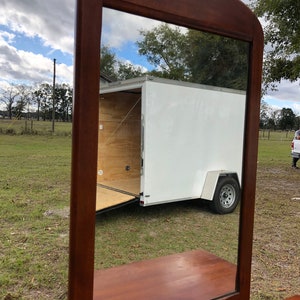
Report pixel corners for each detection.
[68,0,101,300]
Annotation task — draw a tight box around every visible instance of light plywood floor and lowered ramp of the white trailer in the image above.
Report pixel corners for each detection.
[96,178,140,211]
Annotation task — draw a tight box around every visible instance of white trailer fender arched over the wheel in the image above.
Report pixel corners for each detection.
[200,170,239,201]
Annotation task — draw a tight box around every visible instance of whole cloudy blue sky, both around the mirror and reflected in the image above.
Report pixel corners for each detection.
[0,0,300,115]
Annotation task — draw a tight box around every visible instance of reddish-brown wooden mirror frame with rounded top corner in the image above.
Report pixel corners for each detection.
[68,0,263,300]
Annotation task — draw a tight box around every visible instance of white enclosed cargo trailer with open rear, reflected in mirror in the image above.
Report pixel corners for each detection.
[96,76,246,213]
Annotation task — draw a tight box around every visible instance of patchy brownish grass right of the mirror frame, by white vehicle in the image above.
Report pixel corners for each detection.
[252,133,300,300]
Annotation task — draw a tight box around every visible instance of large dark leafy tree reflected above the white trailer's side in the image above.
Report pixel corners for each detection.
[137,24,249,90]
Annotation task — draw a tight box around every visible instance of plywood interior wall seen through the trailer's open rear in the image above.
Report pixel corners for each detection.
[97,89,141,193]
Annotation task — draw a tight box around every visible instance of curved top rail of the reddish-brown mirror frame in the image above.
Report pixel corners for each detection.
[102,0,262,42]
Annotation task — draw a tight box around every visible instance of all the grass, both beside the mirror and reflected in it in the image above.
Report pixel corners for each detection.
[0,124,300,299]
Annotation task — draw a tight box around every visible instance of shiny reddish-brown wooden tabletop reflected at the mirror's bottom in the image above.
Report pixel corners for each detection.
[93,250,236,300]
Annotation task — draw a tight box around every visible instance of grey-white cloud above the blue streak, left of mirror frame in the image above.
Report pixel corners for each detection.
[0,0,75,53]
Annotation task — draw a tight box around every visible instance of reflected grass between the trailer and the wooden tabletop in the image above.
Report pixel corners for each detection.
[95,201,239,269]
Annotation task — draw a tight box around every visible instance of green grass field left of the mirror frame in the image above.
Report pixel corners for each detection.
[0,135,71,299]
